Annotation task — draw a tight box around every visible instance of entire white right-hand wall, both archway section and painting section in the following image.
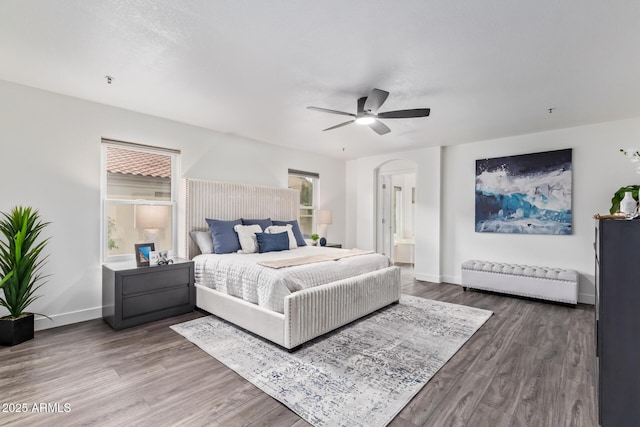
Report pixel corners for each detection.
[346,118,640,303]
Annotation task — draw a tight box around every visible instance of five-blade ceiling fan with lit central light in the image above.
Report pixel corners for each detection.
[307,89,431,135]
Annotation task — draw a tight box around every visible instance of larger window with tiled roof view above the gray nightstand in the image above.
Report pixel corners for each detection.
[102,139,180,261]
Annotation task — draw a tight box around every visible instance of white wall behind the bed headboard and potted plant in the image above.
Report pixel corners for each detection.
[0,81,346,329]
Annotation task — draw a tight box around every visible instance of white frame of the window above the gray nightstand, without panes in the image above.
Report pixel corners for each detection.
[100,138,181,263]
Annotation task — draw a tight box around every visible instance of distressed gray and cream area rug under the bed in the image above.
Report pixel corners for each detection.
[171,296,492,427]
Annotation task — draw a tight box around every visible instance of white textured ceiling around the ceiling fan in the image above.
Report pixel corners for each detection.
[0,0,640,158]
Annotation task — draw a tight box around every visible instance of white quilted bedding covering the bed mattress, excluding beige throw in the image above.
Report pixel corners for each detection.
[193,246,389,313]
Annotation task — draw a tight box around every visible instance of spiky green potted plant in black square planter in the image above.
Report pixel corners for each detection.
[0,206,49,346]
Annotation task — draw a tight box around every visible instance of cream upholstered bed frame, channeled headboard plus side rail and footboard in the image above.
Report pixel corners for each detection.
[180,179,400,350]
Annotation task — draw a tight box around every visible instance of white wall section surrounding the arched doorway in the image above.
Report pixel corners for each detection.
[346,147,440,282]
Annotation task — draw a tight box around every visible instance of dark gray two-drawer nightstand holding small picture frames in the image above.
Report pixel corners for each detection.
[102,258,196,329]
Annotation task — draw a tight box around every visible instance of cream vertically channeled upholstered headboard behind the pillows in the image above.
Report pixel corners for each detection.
[179,179,300,259]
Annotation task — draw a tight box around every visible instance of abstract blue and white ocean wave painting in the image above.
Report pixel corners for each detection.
[476,148,571,234]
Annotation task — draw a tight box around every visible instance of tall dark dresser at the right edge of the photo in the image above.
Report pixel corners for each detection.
[595,219,640,427]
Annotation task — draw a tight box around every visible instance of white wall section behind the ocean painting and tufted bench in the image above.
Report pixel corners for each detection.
[442,118,640,303]
